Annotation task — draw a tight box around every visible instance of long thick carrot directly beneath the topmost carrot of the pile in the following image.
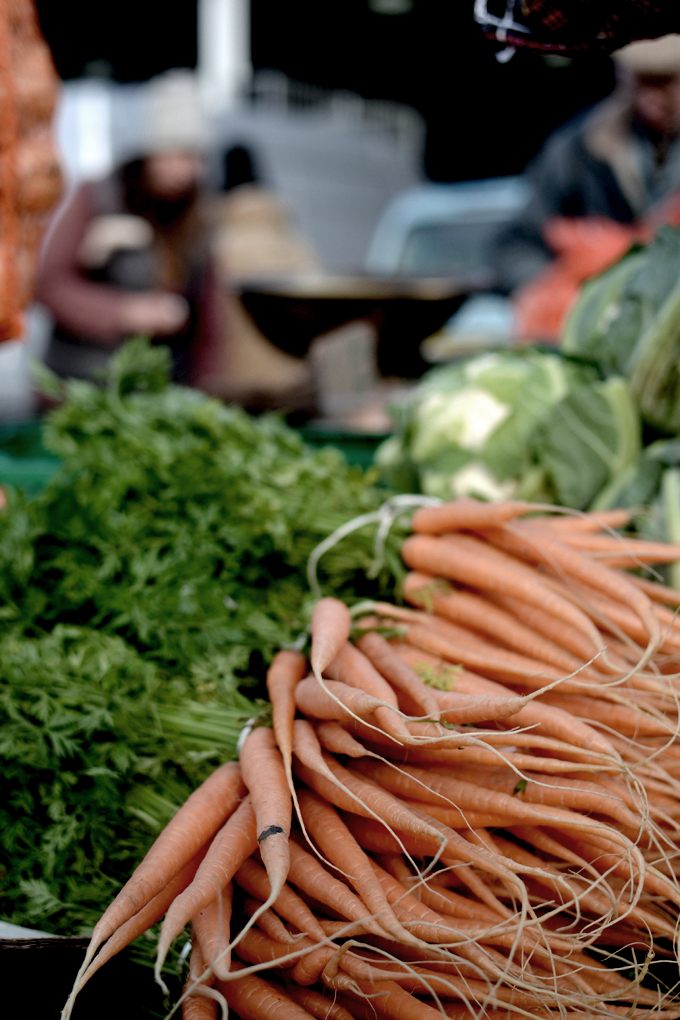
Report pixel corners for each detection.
[402,534,601,658]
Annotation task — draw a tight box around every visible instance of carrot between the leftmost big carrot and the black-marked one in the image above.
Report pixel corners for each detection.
[154,796,257,987]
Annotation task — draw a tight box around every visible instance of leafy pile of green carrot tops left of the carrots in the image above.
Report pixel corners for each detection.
[0,341,399,934]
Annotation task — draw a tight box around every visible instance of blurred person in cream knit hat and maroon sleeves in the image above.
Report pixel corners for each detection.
[37,70,220,386]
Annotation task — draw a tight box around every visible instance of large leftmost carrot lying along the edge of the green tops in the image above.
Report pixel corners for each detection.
[71,762,246,987]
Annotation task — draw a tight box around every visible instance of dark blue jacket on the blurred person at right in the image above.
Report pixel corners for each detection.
[494,95,680,293]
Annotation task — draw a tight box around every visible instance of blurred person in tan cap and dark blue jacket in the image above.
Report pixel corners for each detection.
[494,35,680,293]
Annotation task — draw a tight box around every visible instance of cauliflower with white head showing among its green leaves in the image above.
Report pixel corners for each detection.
[376,350,640,509]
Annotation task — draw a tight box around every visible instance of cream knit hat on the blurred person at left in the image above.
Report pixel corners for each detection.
[144,68,208,154]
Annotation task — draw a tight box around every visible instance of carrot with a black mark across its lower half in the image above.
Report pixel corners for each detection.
[240,726,293,910]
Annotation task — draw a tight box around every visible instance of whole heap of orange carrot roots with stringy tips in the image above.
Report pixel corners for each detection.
[62,500,680,1020]
